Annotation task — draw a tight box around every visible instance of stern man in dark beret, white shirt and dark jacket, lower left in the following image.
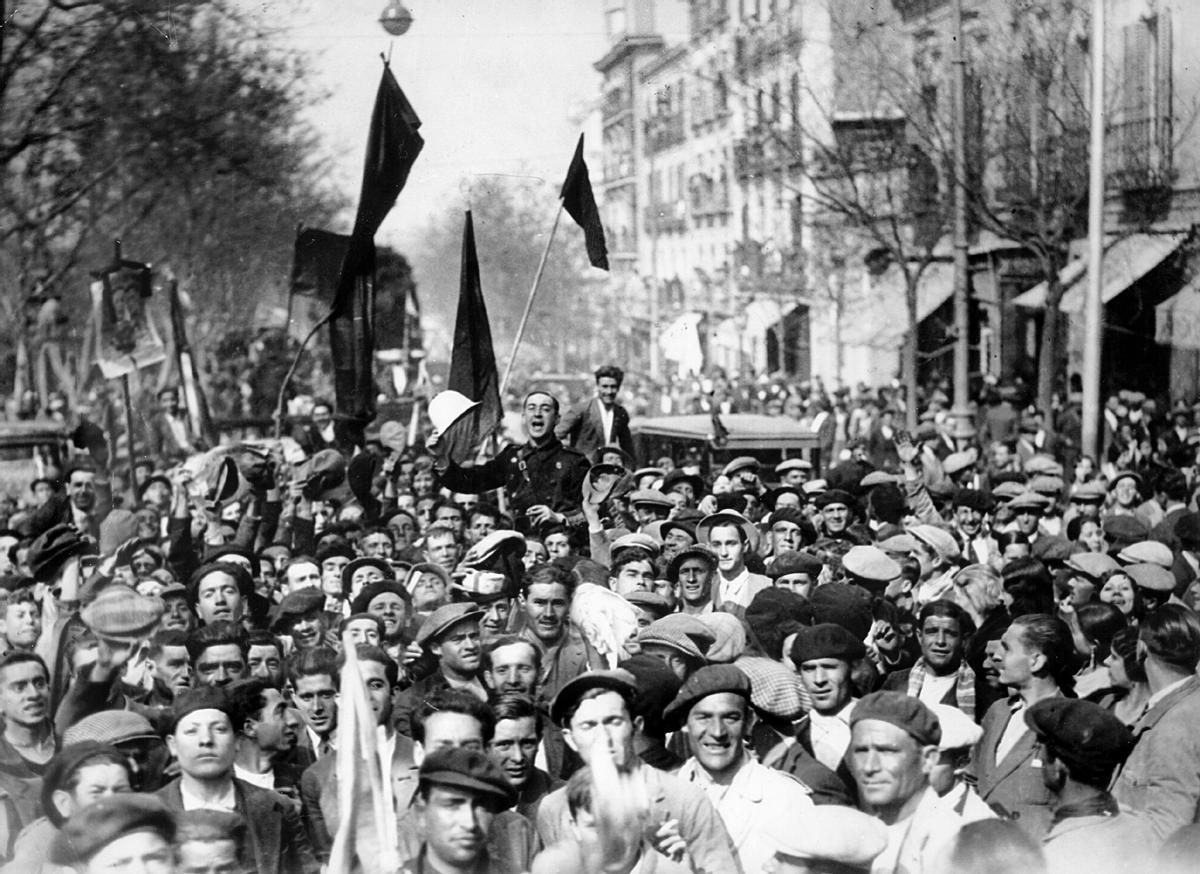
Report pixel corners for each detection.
[155,687,318,874]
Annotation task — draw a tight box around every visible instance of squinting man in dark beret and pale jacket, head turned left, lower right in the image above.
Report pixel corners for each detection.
[846,692,964,874]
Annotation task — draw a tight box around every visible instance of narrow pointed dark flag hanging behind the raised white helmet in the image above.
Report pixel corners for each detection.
[446,210,503,460]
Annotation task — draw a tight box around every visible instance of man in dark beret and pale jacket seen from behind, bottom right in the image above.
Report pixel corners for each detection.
[1025,698,1156,874]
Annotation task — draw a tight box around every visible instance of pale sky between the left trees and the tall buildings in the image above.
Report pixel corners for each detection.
[240,0,624,251]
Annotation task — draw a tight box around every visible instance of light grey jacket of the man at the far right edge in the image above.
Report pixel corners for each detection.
[1112,676,1200,842]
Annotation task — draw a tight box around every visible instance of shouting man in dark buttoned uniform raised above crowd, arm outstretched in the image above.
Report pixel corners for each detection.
[428,391,589,533]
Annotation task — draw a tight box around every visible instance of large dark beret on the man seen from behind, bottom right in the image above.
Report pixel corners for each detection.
[1025,698,1134,786]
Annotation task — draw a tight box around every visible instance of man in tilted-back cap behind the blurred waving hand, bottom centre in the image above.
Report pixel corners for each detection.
[538,669,742,874]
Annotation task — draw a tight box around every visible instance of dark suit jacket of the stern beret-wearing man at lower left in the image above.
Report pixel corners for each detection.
[155,778,318,874]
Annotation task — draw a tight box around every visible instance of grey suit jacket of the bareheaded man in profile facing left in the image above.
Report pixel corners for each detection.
[971,700,1052,842]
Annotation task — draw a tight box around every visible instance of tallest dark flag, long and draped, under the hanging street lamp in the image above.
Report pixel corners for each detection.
[329,64,425,425]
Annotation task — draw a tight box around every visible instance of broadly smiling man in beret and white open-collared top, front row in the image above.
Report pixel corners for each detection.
[662,665,814,872]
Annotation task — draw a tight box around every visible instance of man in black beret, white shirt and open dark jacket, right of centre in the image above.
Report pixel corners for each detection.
[776,622,866,804]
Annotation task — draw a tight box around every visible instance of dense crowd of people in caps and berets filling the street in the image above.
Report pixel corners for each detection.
[0,366,1200,874]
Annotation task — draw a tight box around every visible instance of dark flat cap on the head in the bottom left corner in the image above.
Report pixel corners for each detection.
[50,792,175,866]
